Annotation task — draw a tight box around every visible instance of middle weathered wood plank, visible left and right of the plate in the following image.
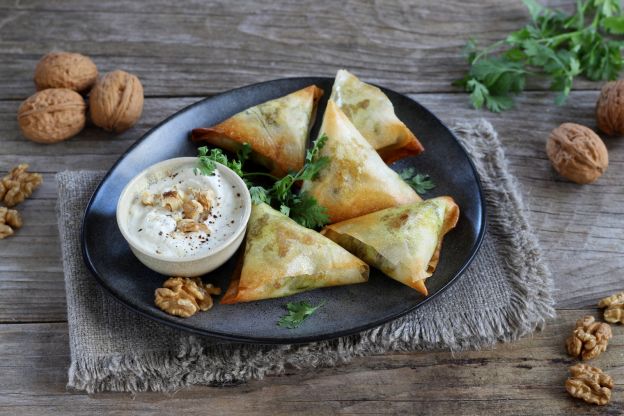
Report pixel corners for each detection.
[0,92,624,322]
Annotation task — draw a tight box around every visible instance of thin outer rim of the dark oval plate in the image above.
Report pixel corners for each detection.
[80,77,488,345]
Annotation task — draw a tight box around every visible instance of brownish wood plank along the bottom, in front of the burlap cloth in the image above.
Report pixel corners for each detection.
[0,310,624,415]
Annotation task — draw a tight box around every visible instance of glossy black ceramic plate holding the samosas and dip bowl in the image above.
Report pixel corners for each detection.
[82,78,485,343]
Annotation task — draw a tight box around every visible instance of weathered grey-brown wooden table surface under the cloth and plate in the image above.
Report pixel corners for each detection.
[0,0,624,416]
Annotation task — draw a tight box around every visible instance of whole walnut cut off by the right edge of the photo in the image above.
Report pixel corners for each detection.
[596,80,624,136]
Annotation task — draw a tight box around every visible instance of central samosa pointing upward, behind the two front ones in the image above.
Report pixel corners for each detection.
[302,100,421,223]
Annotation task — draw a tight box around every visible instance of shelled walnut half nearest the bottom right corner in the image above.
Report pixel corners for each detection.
[566,364,613,406]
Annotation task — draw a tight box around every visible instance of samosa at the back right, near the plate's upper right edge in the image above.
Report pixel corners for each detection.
[330,69,424,164]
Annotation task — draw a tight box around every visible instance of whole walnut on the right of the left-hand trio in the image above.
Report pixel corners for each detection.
[89,71,143,133]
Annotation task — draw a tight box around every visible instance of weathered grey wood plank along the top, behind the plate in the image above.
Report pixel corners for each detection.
[0,0,596,99]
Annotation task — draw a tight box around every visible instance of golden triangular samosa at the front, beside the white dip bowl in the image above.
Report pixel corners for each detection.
[221,203,369,304]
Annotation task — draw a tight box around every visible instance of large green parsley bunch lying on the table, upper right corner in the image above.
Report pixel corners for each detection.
[454,0,624,112]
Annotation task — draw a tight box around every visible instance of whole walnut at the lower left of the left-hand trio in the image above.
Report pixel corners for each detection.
[17,88,87,143]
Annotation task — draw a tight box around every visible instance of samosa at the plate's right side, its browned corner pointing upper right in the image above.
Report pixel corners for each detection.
[322,196,459,296]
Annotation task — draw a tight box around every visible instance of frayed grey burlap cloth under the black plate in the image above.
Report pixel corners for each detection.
[57,120,554,392]
